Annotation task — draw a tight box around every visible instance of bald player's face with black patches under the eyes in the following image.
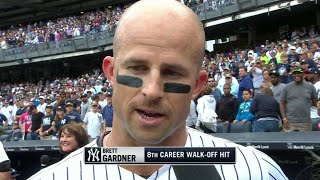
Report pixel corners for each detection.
[104,15,207,144]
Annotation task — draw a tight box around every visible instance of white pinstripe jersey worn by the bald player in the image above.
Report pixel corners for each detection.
[29,129,288,180]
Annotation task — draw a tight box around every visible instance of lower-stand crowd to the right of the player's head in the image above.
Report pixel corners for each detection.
[187,36,320,133]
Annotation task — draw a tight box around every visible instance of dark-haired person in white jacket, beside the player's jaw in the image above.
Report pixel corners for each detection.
[196,85,218,133]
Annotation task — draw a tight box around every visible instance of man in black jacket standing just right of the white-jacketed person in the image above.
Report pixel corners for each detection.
[217,83,240,126]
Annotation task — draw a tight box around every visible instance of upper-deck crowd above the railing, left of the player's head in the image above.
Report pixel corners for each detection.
[0,3,131,49]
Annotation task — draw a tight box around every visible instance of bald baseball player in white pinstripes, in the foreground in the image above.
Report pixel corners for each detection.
[29,0,288,180]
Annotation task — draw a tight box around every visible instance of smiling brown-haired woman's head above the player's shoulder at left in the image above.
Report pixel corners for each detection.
[58,122,89,156]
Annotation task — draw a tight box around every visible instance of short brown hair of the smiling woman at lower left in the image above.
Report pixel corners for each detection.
[58,122,89,153]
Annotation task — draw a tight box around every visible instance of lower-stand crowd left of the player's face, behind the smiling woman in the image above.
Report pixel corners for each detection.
[0,74,113,140]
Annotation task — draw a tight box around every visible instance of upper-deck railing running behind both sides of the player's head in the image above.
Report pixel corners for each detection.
[0,0,280,62]
